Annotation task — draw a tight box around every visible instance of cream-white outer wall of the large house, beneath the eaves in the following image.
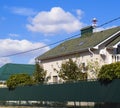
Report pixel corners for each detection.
[39,48,113,83]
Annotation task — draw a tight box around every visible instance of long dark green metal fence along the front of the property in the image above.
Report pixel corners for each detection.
[0,80,120,103]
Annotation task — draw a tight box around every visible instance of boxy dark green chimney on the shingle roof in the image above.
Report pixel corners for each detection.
[81,26,93,37]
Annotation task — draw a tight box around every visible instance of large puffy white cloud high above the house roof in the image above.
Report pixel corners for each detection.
[26,7,84,34]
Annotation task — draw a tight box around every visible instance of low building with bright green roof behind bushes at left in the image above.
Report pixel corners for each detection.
[0,63,35,87]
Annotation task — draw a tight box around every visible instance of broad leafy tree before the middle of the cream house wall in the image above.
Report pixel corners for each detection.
[54,59,87,81]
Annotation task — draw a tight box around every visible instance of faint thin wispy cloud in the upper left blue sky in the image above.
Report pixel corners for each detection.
[10,7,37,16]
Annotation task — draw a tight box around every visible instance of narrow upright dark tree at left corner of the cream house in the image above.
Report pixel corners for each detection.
[33,63,47,83]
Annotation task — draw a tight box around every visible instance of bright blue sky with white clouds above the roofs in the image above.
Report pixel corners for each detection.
[0,0,120,66]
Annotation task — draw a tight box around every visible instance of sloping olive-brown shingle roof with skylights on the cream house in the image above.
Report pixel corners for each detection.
[37,27,120,60]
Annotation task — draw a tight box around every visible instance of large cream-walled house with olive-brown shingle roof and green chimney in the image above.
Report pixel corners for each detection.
[36,26,120,82]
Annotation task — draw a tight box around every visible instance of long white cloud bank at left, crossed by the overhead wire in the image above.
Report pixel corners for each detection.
[0,39,50,61]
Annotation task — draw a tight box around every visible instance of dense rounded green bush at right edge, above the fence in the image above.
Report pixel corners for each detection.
[98,62,120,81]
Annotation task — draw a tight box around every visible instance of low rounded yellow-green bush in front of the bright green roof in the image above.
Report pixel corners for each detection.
[7,73,33,89]
